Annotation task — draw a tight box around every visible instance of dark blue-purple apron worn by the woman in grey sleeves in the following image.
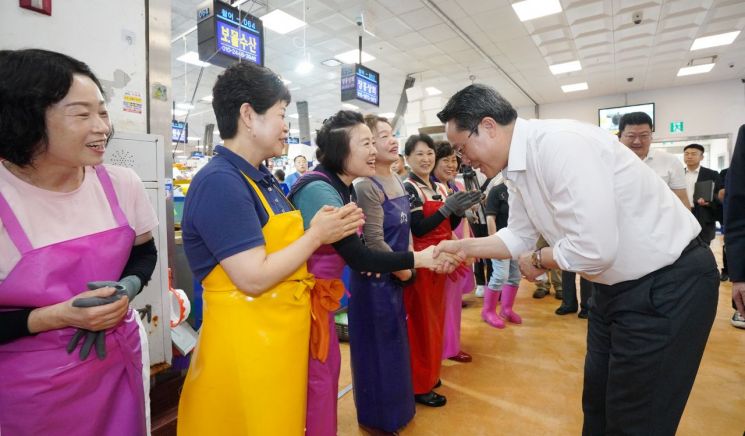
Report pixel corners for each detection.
[349,177,415,432]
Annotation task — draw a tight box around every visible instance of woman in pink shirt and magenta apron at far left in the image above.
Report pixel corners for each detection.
[0,50,157,436]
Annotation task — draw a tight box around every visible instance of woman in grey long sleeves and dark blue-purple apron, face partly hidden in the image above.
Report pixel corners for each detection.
[349,115,415,433]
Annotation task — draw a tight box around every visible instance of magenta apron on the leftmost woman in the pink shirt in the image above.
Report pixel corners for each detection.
[0,166,146,436]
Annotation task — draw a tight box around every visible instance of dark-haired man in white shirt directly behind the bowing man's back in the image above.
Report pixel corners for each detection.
[618,112,691,210]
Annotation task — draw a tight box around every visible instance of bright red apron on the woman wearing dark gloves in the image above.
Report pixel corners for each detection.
[404,185,452,394]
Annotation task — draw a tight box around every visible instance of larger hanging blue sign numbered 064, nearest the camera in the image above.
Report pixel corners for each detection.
[197,0,264,68]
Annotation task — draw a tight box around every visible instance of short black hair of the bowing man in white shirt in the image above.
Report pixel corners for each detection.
[437,83,517,132]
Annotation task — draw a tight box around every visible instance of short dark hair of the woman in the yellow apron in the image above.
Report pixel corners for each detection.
[212,62,291,139]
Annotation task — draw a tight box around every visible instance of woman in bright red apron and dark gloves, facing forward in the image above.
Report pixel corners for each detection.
[404,134,481,407]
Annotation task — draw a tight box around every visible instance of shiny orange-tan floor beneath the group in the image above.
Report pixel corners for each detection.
[339,241,745,435]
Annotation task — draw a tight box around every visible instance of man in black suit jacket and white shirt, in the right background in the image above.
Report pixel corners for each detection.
[683,144,723,243]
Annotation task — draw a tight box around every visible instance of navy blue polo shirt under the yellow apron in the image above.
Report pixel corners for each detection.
[181,146,292,282]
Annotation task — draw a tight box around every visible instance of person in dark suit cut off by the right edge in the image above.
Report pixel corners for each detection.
[724,124,745,328]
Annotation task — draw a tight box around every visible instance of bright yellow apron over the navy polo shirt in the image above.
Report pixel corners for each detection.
[178,174,314,436]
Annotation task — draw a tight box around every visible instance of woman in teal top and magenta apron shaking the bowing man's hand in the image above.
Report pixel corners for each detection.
[290,111,457,436]
